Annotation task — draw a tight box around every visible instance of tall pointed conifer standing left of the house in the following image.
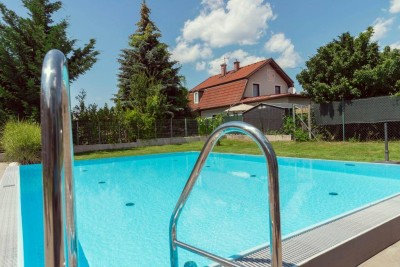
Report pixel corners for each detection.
[115,1,190,116]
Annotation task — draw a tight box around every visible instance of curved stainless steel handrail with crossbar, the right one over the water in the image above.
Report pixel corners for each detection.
[169,122,282,267]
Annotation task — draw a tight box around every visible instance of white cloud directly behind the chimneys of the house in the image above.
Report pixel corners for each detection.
[207,49,265,75]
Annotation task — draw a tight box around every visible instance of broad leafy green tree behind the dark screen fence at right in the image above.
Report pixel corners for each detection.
[297,27,400,103]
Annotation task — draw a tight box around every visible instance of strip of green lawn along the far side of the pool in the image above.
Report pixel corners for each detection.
[75,139,400,162]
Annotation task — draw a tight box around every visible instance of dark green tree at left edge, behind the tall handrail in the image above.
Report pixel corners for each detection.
[0,0,99,121]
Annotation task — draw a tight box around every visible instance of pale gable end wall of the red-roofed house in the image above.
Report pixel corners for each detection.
[244,64,289,97]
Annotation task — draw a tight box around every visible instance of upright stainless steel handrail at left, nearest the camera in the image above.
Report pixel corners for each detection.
[40,50,77,267]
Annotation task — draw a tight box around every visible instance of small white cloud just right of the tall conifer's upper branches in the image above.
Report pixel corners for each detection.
[171,38,212,64]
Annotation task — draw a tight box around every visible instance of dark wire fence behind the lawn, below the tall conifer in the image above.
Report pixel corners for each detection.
[72,119,199,145]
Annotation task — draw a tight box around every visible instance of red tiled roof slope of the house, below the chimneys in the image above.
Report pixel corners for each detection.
[189,79,247,110]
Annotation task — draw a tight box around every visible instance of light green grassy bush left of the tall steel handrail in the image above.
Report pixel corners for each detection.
[1,121,41,164]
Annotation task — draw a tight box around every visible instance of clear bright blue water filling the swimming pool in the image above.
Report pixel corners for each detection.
[20,152,400,267]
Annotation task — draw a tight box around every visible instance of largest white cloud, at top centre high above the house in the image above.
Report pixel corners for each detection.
[182,0,274,47]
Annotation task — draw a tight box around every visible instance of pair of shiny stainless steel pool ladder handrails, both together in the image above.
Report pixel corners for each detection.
[40,50,282,267]
